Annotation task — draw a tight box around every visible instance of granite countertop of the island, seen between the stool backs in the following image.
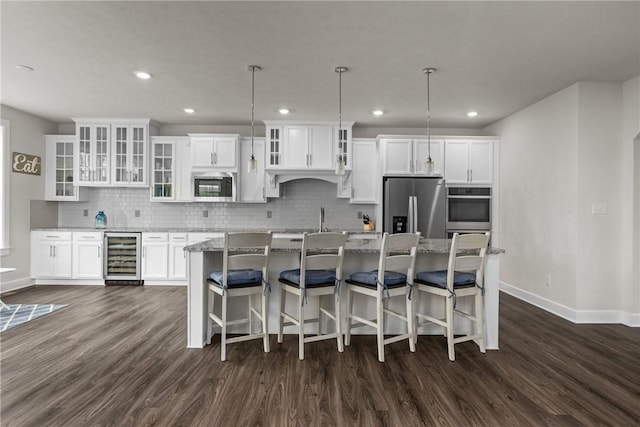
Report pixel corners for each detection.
[185,236,505,254]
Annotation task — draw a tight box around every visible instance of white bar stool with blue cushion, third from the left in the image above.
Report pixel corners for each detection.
[345,233,420,362]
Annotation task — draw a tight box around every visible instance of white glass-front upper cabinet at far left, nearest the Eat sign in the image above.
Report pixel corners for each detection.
[44,135,88,202]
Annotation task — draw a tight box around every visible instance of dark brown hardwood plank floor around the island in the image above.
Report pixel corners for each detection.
[0,286,640,427]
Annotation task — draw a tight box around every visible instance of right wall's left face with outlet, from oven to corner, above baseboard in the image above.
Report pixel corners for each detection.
[486,85,578,307]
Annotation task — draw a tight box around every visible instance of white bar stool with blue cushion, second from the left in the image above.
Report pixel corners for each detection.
[278,233,347,360]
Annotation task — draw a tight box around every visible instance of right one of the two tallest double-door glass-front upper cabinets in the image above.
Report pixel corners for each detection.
[111,124,149,187]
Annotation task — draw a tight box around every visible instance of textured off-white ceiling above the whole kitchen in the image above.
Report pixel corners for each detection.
[0,1,640,128]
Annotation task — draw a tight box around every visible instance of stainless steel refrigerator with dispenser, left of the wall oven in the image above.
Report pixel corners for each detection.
[382,177,446,239]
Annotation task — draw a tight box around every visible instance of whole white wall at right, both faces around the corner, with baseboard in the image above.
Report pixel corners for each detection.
[485,78,640,325]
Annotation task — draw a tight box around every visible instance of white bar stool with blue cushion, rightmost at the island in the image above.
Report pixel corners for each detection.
[415,233,489,362]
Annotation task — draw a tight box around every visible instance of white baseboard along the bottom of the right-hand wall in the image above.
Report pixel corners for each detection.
[500,281,640,327]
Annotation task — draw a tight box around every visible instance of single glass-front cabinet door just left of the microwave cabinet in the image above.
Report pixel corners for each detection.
[151,137,176,200]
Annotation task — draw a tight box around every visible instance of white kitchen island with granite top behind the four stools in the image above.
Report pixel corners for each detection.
[185,236,504,349]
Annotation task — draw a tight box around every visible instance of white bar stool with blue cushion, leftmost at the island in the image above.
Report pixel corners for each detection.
[207,232,271,361]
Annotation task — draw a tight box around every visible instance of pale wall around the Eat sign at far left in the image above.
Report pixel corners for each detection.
[0,105,57,291]
